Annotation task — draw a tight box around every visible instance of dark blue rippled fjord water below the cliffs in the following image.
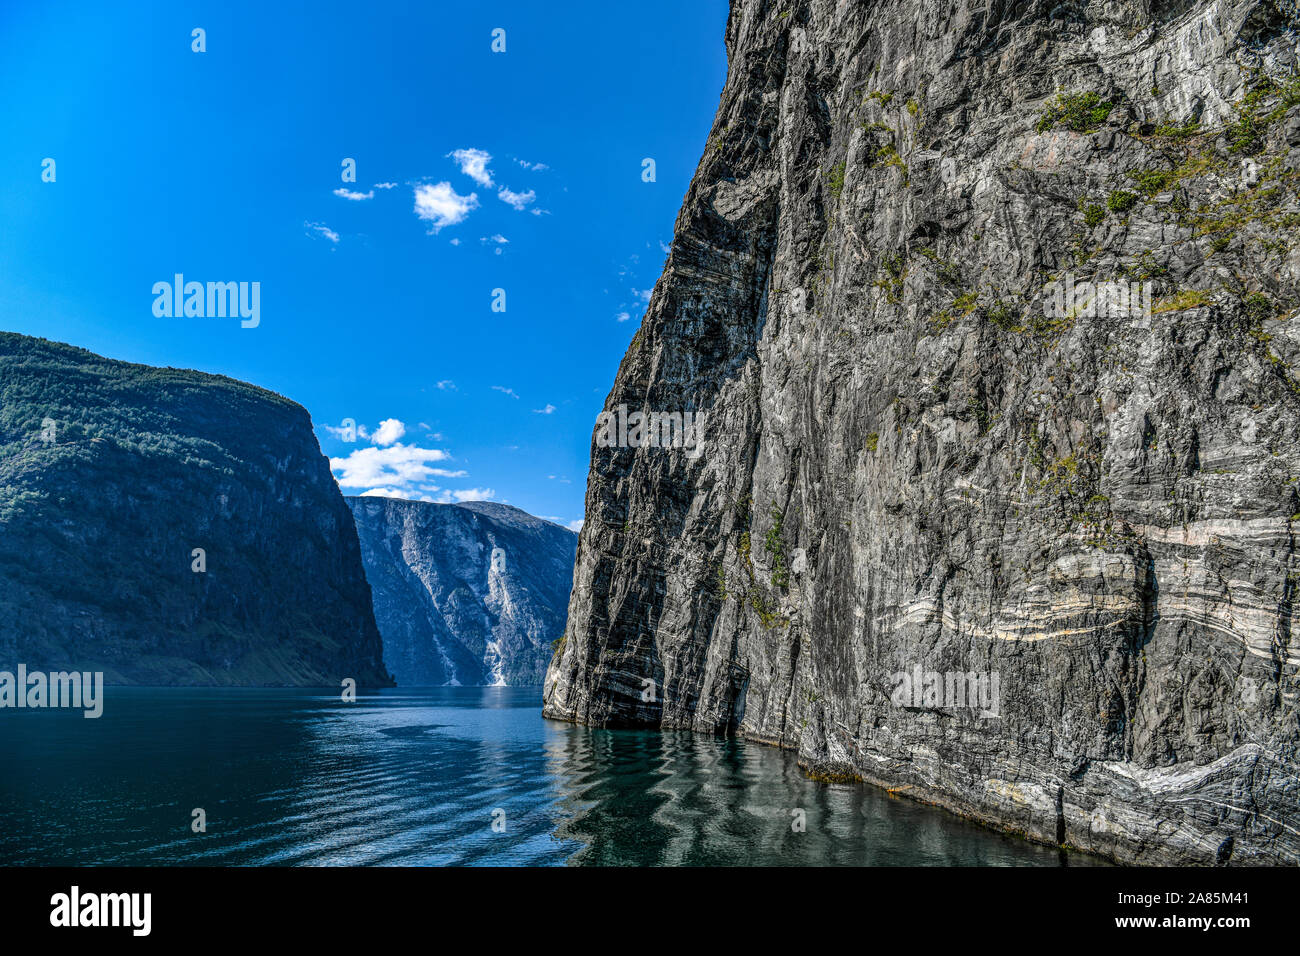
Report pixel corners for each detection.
[0,687,1092,866]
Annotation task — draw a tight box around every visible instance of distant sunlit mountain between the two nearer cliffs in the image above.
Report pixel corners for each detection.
[347,497,577,687]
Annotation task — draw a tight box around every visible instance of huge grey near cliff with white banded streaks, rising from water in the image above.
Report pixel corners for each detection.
[543,0,1300,864]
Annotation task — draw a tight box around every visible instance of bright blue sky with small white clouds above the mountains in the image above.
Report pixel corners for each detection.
[0,0,727,524]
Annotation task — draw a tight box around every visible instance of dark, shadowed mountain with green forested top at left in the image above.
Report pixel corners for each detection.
[0,333,391,688]
